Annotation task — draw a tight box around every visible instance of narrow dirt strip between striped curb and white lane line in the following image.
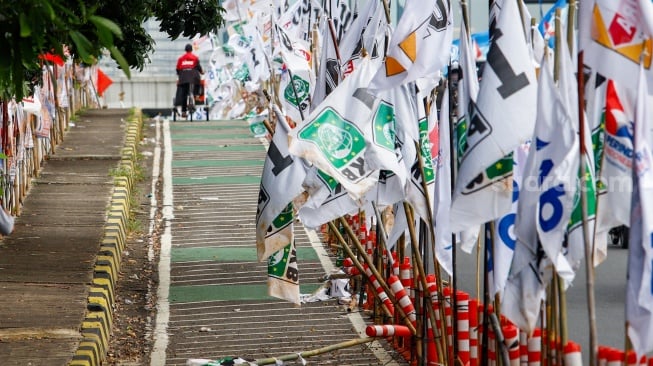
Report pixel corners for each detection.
[106,117,161,366]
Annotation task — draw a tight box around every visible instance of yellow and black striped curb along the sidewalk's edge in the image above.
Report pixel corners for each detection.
[68,110,143,366]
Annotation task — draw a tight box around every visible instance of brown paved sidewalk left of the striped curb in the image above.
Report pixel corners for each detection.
[0,110,133,366]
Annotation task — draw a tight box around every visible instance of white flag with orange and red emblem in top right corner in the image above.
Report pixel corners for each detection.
[578,0,653,91]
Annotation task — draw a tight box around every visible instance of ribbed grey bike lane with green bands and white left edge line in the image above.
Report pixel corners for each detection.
[152,121,408,365]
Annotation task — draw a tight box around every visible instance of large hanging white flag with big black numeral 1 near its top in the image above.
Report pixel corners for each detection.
[451,1,537,232]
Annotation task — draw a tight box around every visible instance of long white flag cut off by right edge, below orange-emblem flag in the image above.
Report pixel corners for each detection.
[626,68,653,356]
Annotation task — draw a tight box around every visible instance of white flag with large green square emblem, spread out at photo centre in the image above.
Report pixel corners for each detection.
[289,59,378,200]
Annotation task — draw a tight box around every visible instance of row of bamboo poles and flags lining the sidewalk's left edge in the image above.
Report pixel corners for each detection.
[0,62,99,215]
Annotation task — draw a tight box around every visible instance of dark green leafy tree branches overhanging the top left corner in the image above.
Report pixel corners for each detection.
[0,0,224,99]
